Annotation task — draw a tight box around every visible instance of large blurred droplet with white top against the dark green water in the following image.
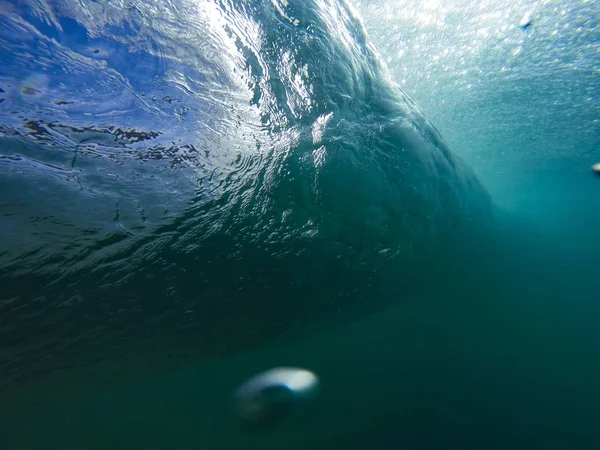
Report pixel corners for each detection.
[235,367,319,424]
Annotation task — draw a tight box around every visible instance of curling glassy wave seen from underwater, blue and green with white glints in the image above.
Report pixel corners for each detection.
[0,0,492,379]
